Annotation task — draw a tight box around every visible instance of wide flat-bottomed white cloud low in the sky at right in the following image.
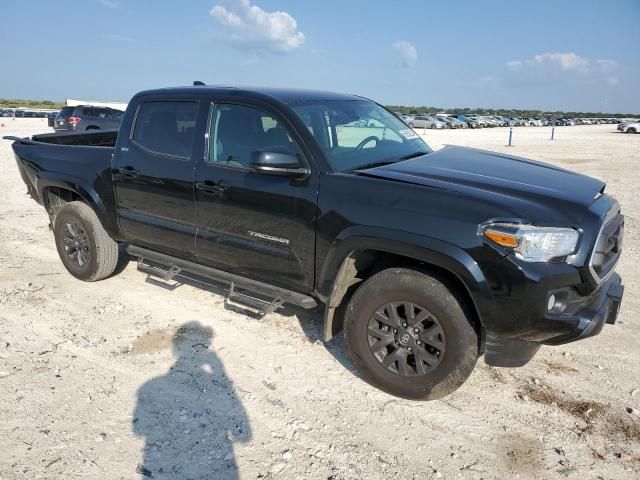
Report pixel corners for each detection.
[507,52,619,85]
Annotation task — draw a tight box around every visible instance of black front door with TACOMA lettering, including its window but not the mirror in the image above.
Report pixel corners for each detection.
[195,101,318,292]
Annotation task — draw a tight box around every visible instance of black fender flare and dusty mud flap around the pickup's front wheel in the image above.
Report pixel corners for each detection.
[317,226,493,342]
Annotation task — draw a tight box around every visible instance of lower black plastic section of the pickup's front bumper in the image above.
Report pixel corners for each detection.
[485,273,624,367]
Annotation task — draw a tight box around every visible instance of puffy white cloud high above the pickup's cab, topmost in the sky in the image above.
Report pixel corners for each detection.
[209,0,304,53]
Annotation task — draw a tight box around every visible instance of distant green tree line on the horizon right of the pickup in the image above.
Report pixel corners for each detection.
[387,105,640,118]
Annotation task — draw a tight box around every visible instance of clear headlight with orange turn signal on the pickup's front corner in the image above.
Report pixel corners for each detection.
[483,223,580,262]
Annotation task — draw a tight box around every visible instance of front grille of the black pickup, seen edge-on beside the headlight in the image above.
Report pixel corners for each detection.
[589,205,624,281]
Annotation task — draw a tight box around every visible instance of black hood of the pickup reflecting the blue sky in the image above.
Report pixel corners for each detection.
[364,146,605,208]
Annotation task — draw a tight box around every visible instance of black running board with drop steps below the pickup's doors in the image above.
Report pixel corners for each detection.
[127,245,318,315]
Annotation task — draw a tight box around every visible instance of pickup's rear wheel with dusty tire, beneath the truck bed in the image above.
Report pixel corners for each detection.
[53,202,118,282]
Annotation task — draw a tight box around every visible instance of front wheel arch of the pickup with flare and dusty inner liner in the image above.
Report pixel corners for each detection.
[318,227,492,341]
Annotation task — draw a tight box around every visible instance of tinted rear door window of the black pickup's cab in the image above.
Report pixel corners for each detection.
[131,101,198,159]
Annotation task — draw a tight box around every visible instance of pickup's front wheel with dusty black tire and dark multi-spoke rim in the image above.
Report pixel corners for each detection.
[344,268,479,400]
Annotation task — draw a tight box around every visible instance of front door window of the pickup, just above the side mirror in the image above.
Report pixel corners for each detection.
[207,104,296,168]
